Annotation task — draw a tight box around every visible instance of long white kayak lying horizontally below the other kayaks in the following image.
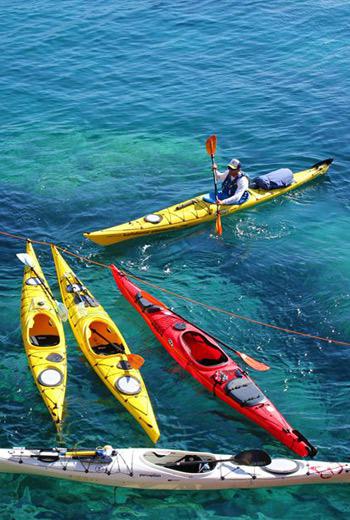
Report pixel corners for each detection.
[0,446,350,490]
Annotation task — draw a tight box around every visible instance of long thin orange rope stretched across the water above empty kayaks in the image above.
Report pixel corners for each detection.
[0,231,350,347]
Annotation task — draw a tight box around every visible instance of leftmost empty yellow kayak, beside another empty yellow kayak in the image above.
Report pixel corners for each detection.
[18,241,67,431]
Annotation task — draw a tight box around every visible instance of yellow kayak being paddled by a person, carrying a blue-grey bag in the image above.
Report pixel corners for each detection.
[84,159,332,246]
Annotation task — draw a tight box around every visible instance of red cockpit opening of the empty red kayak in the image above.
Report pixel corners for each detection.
[181,331,228,367]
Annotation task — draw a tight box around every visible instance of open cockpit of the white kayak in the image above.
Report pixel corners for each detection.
[143,451,217,473]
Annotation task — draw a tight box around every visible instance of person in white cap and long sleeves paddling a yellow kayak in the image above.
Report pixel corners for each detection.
[213,159,249,205]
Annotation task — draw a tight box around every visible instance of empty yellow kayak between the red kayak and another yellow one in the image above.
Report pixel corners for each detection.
[51,246,160,442]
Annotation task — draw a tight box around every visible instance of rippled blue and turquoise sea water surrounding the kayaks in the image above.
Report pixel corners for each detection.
[0,0,350,520]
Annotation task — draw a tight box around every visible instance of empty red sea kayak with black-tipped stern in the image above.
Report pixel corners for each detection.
[111,265,317,457]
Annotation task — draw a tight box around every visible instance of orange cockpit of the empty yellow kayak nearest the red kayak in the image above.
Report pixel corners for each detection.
[86,320,124,356]
